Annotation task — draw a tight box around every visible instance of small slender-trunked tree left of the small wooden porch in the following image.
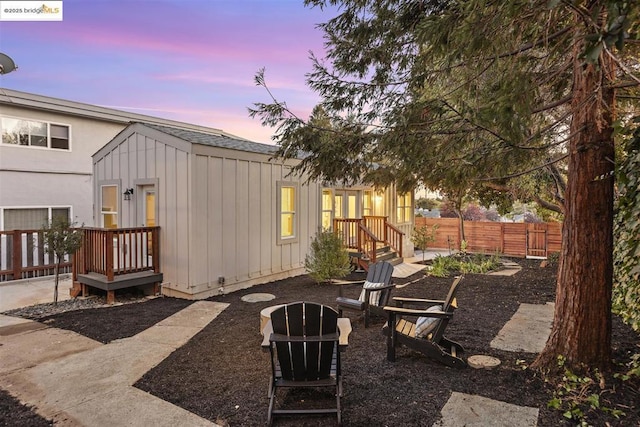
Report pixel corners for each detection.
[41,217,82,304]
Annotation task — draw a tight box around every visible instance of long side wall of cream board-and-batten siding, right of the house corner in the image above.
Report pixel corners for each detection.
[189,155,320,296]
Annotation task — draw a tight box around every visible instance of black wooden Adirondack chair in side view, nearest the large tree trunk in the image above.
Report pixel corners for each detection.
[383,276,467,368]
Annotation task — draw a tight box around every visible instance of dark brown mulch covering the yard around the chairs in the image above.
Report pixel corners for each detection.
[0,260,640,426]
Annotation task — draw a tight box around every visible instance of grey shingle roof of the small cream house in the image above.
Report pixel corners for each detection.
[142,123,278,155]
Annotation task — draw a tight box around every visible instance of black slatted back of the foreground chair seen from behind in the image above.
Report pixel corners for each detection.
[271,302,338,381]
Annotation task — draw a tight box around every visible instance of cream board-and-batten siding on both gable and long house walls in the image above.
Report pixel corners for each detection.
[94,125,321,299]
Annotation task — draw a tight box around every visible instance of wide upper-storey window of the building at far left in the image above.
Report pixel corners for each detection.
[0,117,69,150]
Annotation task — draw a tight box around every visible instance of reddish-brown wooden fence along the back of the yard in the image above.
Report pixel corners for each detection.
[415,217,562,258]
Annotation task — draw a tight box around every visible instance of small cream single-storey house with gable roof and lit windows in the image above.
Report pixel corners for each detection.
[93,123,414,299]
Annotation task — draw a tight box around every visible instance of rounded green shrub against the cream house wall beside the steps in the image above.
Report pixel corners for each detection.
[304,230,351,283]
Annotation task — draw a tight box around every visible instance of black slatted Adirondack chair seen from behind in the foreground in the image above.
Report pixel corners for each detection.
[262,302,351,425]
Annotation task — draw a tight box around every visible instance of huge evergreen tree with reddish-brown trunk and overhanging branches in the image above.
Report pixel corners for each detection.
[250,0,640,371]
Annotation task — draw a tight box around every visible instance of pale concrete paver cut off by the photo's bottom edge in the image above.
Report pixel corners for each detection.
[433,391,538,427]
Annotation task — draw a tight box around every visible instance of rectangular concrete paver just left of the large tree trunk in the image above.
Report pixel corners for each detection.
[490,303,555,353]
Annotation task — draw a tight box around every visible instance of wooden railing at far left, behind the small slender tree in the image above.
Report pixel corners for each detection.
[0,230,71,282]
